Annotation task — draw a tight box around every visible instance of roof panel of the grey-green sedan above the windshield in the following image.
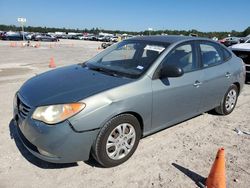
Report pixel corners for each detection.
[127,35,211,44]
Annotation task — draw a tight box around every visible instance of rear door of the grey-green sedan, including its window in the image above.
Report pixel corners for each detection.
[197,41,232,112]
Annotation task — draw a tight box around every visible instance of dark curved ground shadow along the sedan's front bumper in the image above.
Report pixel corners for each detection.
[9,119,78,169]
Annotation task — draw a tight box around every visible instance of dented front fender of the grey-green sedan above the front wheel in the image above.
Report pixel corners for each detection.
[69,77,152,132]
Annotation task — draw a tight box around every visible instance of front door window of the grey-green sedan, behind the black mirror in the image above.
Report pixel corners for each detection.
[164,44,198,72]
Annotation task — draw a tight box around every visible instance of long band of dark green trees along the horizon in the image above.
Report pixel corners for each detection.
[0,25,250,39]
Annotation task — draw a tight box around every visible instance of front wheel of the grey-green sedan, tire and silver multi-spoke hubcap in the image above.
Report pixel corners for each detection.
[92,114,141,167]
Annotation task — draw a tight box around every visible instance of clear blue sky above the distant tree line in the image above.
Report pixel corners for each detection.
[0,0,250,32]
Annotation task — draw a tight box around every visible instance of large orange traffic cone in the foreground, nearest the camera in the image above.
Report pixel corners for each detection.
[206,148,226,188]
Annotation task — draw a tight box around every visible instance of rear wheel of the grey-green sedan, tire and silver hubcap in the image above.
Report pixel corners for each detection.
[215,84,239,115]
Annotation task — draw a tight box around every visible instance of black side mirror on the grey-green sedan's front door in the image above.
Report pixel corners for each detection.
[160,65,184,78]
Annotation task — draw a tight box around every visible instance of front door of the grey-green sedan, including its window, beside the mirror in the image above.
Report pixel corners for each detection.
[152,42,202,130]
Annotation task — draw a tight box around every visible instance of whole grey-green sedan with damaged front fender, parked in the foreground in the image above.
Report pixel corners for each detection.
[14,36,245,167]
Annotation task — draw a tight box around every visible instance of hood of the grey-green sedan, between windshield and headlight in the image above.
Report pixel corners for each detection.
[19,65,133,107]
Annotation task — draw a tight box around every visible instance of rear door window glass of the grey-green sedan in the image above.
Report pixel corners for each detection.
[200,43,223,67]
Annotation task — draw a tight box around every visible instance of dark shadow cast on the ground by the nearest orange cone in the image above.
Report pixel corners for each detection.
[172,163,206,188]
